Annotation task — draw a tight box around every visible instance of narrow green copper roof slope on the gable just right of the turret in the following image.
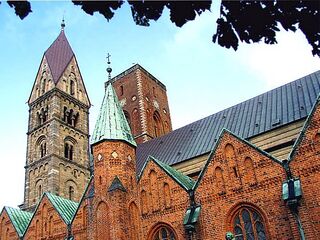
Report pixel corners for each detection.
[149,156,195,191]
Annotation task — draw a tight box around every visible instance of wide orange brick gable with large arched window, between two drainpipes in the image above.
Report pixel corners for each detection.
[194,130,291,239]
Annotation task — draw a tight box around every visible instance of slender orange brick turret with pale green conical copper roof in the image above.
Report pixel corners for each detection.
[88,77,138,240]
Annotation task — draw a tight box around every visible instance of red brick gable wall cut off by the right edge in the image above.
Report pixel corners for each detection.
[290,101,320,236]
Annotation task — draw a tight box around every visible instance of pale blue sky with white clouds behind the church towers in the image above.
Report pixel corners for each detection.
[0,1,320,208]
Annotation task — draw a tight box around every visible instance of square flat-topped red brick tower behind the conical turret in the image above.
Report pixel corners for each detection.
[106,64,172,143]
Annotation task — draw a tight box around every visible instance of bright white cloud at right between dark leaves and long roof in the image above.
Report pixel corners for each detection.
[238,30,320,89]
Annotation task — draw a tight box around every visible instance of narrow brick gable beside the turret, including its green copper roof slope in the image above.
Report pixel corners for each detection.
[138,157,194,239]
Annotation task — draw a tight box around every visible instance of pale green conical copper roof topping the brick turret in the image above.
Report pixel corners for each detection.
[91,83,136,146]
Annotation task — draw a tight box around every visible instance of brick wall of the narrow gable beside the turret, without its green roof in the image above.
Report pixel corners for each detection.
[138,161,189,239]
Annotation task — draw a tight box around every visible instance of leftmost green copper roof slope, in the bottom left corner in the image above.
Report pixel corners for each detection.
[5,207,33,237]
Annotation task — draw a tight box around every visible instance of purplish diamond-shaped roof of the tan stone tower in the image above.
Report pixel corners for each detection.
[44,30,74,84]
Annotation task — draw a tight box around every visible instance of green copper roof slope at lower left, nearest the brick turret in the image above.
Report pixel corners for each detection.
[45,193,79,225]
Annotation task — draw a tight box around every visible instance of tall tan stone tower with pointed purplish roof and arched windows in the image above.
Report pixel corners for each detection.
[21,22,91,209]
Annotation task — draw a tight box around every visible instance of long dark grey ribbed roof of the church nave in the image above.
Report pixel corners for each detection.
[137,71,320,172]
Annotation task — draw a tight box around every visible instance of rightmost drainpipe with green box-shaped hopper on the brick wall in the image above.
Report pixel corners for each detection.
[282,160,306,240]
